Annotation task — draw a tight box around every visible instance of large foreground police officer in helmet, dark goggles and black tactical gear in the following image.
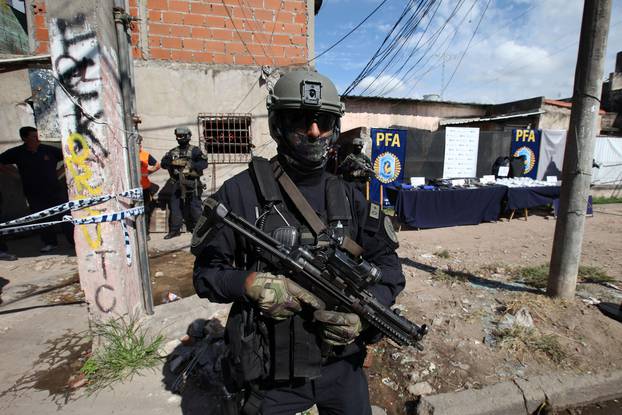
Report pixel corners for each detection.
[192,70,405,415]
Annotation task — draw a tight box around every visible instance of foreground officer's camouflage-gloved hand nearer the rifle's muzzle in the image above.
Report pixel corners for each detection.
[313,310,363,346]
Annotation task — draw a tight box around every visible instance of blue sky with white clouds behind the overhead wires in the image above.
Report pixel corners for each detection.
[315,0,622,103]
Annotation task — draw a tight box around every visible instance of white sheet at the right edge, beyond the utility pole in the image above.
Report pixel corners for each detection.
[592,136,622,185]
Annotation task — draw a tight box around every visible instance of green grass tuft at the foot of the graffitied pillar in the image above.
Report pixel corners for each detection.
[80,317,164,393]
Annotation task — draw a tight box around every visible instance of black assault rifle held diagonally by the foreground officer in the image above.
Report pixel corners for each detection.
[203,198,428,350]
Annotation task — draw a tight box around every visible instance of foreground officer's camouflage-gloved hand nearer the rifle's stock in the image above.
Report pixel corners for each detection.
[246,272,324,320]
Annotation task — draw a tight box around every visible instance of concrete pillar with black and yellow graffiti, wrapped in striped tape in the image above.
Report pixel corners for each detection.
[47,0,144,319]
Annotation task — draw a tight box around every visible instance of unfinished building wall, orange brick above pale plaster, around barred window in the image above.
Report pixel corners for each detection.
[26,0,315,184]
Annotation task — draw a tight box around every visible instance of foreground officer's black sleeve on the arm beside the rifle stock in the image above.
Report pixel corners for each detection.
[193,183,250,303]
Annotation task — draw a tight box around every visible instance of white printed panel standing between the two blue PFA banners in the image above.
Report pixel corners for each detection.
[443,127,479,179]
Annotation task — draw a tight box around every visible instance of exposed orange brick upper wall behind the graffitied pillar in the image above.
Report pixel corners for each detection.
[31,0,308,66]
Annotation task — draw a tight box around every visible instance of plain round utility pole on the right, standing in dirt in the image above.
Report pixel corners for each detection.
[547,0,611,298]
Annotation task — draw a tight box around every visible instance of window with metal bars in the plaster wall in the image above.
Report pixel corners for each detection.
[197,113,253,164]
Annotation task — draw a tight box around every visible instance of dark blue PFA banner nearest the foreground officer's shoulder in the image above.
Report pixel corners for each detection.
[369,128,408,206]
